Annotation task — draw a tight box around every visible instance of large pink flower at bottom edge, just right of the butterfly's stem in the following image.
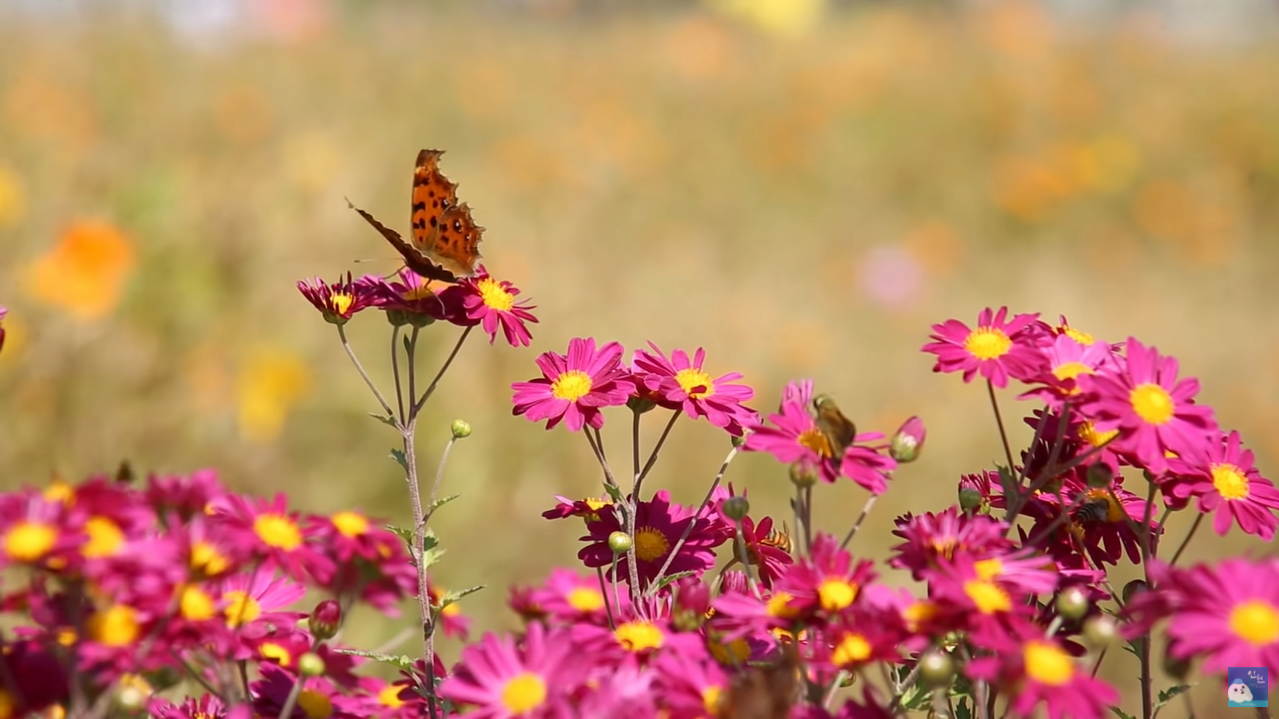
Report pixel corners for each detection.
[440,623,582,719]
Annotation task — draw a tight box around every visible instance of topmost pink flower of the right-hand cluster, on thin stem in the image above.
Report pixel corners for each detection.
[922,307,1046,388]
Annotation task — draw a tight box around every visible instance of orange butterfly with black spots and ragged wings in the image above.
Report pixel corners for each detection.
[347,150,483,283]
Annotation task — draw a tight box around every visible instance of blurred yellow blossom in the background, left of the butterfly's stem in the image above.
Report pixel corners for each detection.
[235,349,311,441]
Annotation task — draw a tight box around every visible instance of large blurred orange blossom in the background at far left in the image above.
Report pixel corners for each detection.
[26,220,134,321]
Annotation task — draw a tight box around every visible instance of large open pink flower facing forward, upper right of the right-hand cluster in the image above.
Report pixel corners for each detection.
[1077,338,1218,475]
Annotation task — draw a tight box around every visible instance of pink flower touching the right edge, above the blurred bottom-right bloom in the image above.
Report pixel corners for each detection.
[1165,431,1279,541]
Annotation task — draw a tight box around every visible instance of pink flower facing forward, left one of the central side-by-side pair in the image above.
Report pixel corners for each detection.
[510,338,633,432]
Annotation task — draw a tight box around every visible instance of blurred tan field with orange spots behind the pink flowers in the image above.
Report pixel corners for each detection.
[0,0,1279,714]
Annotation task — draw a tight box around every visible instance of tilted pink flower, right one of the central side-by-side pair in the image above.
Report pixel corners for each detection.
[634,342,758,436]
